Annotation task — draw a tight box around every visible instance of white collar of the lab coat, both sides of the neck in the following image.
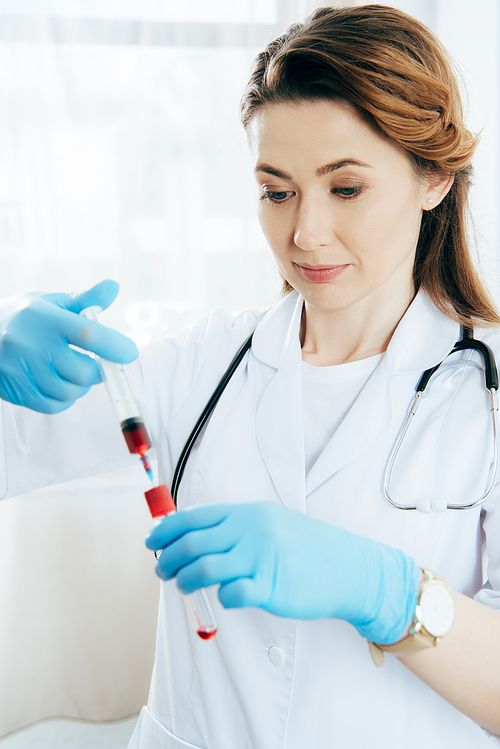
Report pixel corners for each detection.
[252,291,460,374]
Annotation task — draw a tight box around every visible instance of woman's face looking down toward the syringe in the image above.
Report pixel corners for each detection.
[249,100,430,311]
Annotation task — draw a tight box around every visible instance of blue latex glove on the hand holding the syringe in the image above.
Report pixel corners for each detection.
[0,281,138,414]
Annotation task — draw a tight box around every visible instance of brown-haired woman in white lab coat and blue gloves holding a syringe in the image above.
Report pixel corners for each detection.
[0,5,500,749]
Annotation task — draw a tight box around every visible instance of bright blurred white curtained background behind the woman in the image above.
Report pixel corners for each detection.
[0,0,500,749]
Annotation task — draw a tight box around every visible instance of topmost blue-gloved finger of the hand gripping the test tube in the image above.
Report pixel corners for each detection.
[146,504,234,556]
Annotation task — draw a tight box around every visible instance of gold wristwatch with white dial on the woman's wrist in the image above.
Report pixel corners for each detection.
[368,570,456,666]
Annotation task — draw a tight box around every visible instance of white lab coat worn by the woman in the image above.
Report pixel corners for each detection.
[3,292,500,749]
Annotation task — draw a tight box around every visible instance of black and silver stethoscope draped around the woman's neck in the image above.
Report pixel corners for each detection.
[171,327,498,512]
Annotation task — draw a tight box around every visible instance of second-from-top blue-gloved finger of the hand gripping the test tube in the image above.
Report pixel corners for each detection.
[155,521,241,582]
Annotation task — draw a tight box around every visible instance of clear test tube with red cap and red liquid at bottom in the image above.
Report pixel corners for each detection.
[144,484,217,640]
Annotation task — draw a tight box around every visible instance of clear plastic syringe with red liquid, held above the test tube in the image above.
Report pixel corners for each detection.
[80,307,154,481]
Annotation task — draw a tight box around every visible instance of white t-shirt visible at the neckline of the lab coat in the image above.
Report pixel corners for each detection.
[302,354,383,475]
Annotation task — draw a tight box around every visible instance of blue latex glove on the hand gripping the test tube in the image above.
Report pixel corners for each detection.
[146,502,422,644]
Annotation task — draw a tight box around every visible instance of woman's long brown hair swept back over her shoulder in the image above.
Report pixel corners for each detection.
[240,5,500,324]
